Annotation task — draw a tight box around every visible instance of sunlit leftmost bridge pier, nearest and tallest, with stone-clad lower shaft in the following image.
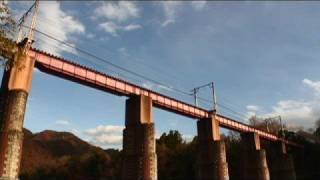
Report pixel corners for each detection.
[0,47,35,180]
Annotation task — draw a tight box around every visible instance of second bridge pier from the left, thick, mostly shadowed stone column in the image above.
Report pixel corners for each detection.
[121,96,158,180]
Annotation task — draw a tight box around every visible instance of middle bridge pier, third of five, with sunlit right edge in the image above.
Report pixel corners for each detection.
[197,117,229,180]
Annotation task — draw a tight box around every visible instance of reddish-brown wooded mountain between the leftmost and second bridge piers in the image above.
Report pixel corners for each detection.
[20,129,121,180]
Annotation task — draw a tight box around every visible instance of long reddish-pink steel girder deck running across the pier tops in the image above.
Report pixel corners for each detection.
[29,49,299,146]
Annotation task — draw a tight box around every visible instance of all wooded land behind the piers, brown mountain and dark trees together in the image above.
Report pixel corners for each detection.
[20,121,320,180]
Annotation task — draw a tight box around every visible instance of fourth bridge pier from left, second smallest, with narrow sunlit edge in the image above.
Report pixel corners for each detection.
[240,133,270,180]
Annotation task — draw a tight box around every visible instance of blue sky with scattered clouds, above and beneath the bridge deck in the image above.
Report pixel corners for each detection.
[3,1,320,147]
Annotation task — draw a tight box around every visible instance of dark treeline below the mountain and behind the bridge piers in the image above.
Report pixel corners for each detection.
[21,125,320,180]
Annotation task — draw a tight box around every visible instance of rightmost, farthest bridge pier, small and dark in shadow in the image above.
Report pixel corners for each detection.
[270,141,296,180]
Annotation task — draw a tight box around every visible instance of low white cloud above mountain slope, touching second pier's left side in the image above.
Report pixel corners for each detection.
[85,125,124,147]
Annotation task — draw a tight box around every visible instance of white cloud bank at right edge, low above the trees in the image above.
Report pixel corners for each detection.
[248,79,320,129]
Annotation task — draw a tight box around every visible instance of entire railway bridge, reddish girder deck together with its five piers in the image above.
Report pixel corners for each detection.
[0,41,301,180]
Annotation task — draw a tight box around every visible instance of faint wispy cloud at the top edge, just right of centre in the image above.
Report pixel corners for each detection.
[161,1,182,27]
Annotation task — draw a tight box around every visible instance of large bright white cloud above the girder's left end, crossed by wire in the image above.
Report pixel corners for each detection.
[36,1,85,55]
